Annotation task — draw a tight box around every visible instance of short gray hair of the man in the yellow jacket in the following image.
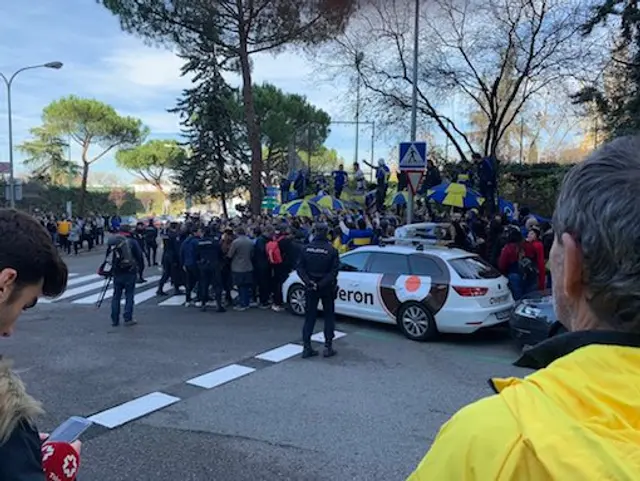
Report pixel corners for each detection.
[553,133,640,332]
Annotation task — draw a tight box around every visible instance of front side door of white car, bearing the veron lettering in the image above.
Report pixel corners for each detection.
[336,250,374,317]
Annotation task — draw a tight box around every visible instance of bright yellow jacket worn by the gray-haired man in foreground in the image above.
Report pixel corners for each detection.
[408,333,640,481]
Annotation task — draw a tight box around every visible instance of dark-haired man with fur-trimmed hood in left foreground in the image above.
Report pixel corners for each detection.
[0,209,80,481]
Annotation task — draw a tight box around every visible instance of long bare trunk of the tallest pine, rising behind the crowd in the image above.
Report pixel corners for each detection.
[239,35,263,214]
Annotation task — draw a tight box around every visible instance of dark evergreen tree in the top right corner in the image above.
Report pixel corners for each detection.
[574,0,640,139]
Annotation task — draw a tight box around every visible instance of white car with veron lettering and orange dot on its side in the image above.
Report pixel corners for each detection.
[283,245,514,341]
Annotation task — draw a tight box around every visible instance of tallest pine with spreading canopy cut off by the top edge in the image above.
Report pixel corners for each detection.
[97,0,358,213]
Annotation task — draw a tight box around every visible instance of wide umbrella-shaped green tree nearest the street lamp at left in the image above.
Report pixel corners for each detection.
[42,95,148,213]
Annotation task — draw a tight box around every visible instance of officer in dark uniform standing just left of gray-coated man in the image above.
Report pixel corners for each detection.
[196,226,225,312]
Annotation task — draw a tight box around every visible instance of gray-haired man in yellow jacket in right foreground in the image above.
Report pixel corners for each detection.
[409,137,640,481]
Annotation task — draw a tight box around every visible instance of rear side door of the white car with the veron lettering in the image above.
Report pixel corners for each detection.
[361,252,410,324]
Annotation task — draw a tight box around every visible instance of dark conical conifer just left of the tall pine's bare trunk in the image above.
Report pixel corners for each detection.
[171,55,251,216]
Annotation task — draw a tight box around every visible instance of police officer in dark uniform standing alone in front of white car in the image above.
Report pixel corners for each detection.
[298,224,340,359]
